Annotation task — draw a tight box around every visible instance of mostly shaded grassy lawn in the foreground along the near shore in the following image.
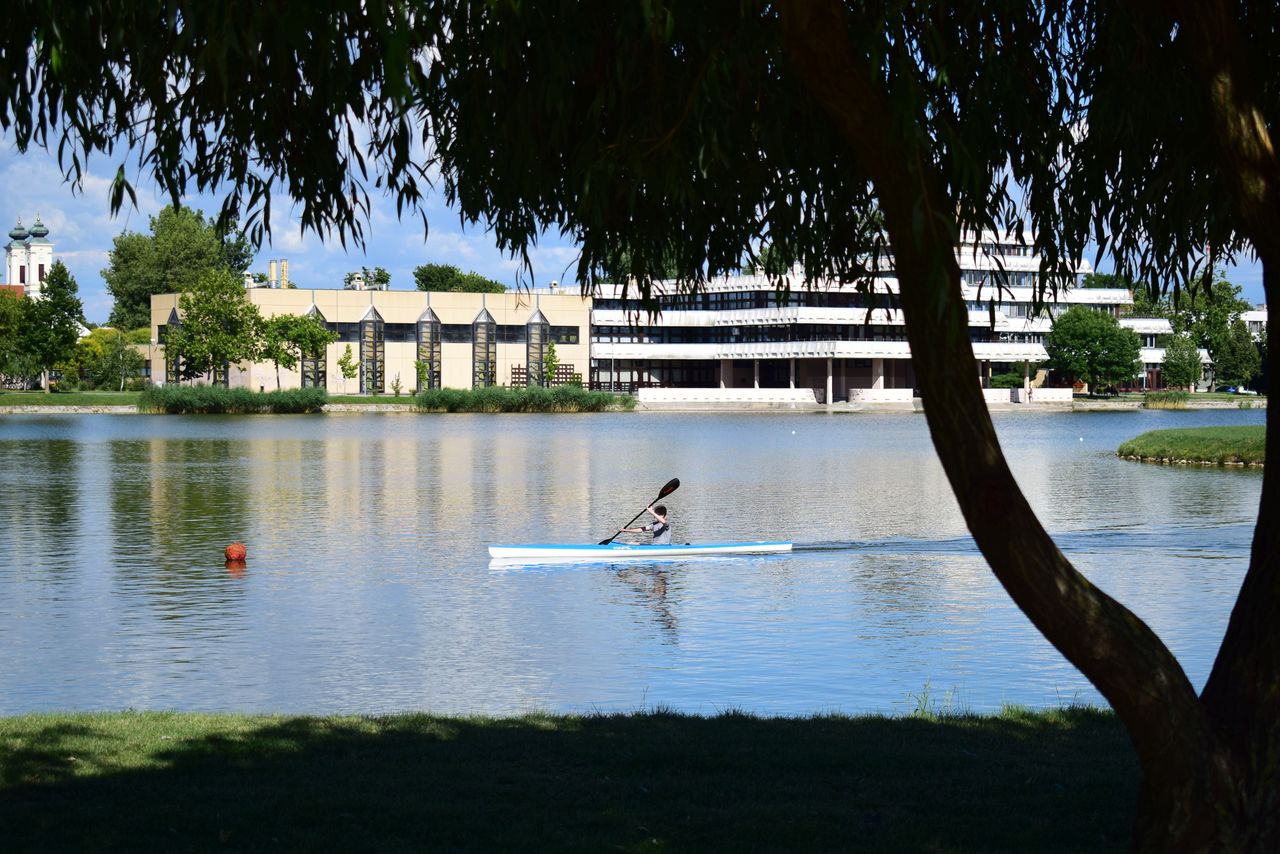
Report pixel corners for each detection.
[0,709,1139,851]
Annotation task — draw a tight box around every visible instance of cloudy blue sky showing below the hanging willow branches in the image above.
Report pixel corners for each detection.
[0,141,1265,323]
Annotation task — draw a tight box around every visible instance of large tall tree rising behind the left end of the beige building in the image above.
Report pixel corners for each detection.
[102,205,253,329]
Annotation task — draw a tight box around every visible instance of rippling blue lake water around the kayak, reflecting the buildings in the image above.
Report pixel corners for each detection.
[0,411,1266,714]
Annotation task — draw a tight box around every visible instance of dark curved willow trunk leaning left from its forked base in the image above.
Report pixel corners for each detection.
[780,0,1280,850]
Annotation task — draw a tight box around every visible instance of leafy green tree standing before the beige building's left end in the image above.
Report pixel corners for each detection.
[165,269,262,384]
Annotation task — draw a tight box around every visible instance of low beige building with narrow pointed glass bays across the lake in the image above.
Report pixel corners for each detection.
[151,288,591,394]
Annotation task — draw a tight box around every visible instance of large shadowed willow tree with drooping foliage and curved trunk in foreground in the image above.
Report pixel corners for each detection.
[0,0,1280,849]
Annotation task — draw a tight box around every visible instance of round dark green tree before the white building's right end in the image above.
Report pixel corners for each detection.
[1044,306,1142,393]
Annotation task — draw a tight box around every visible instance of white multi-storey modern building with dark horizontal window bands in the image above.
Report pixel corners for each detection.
[591,234,1177,403]
